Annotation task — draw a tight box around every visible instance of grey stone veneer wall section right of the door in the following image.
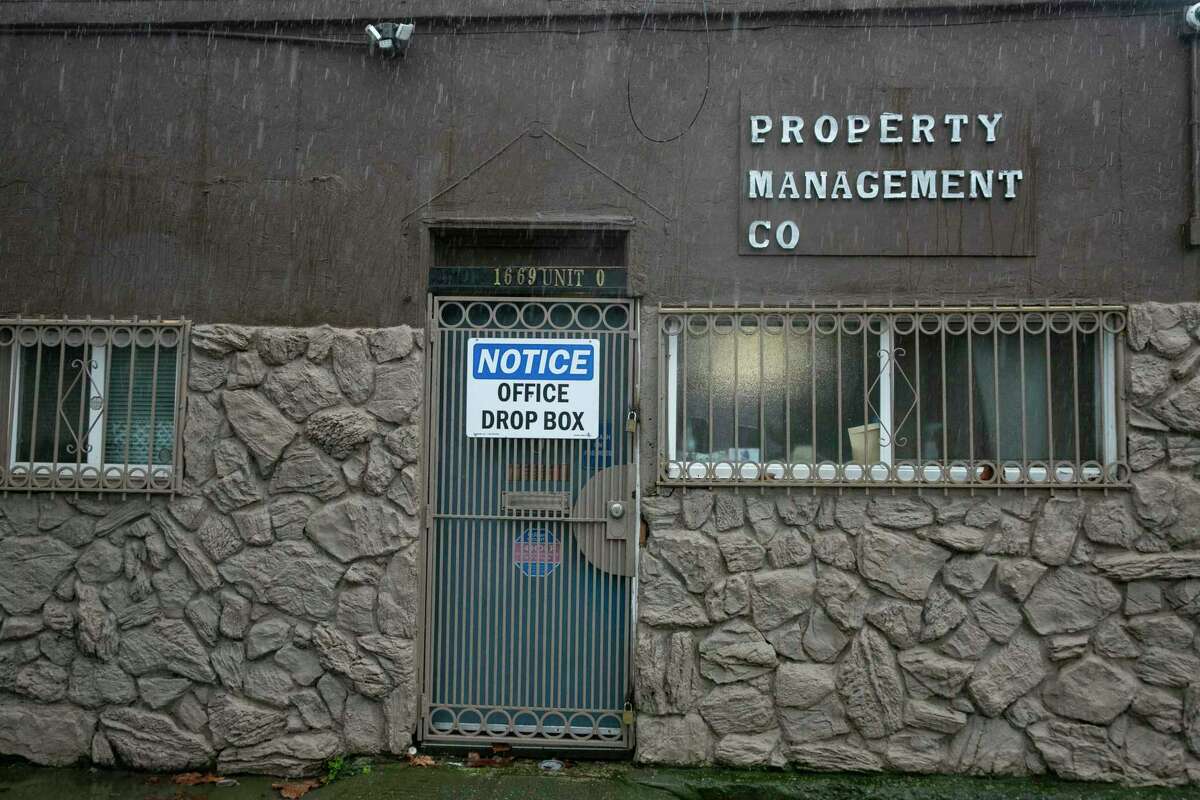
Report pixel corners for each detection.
[635,305,1200,784]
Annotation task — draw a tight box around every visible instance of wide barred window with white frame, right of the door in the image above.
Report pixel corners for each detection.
[659,305,1127,487]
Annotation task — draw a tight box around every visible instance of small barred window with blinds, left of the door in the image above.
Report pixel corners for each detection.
[0,320,187,492]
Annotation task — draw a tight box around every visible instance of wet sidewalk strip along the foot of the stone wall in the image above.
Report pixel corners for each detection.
[0,759,1200,800]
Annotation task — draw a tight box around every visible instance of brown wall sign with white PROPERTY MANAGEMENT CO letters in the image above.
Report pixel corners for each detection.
[738,85,1037,257]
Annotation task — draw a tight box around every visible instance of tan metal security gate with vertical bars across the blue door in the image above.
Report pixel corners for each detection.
[421,297,637,748]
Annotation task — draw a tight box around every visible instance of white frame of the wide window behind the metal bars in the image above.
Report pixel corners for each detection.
[665,330,1118,488]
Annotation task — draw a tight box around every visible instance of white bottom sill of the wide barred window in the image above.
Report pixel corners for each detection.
[665,462,1117,487]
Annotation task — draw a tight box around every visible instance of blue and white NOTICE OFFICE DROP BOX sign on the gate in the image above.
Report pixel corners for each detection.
[467,339,600,439]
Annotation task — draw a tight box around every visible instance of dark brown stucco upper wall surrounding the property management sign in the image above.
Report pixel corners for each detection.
[0,7,1200,326]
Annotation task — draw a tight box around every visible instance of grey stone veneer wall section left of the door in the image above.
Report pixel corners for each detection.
[0,325,422,774]
